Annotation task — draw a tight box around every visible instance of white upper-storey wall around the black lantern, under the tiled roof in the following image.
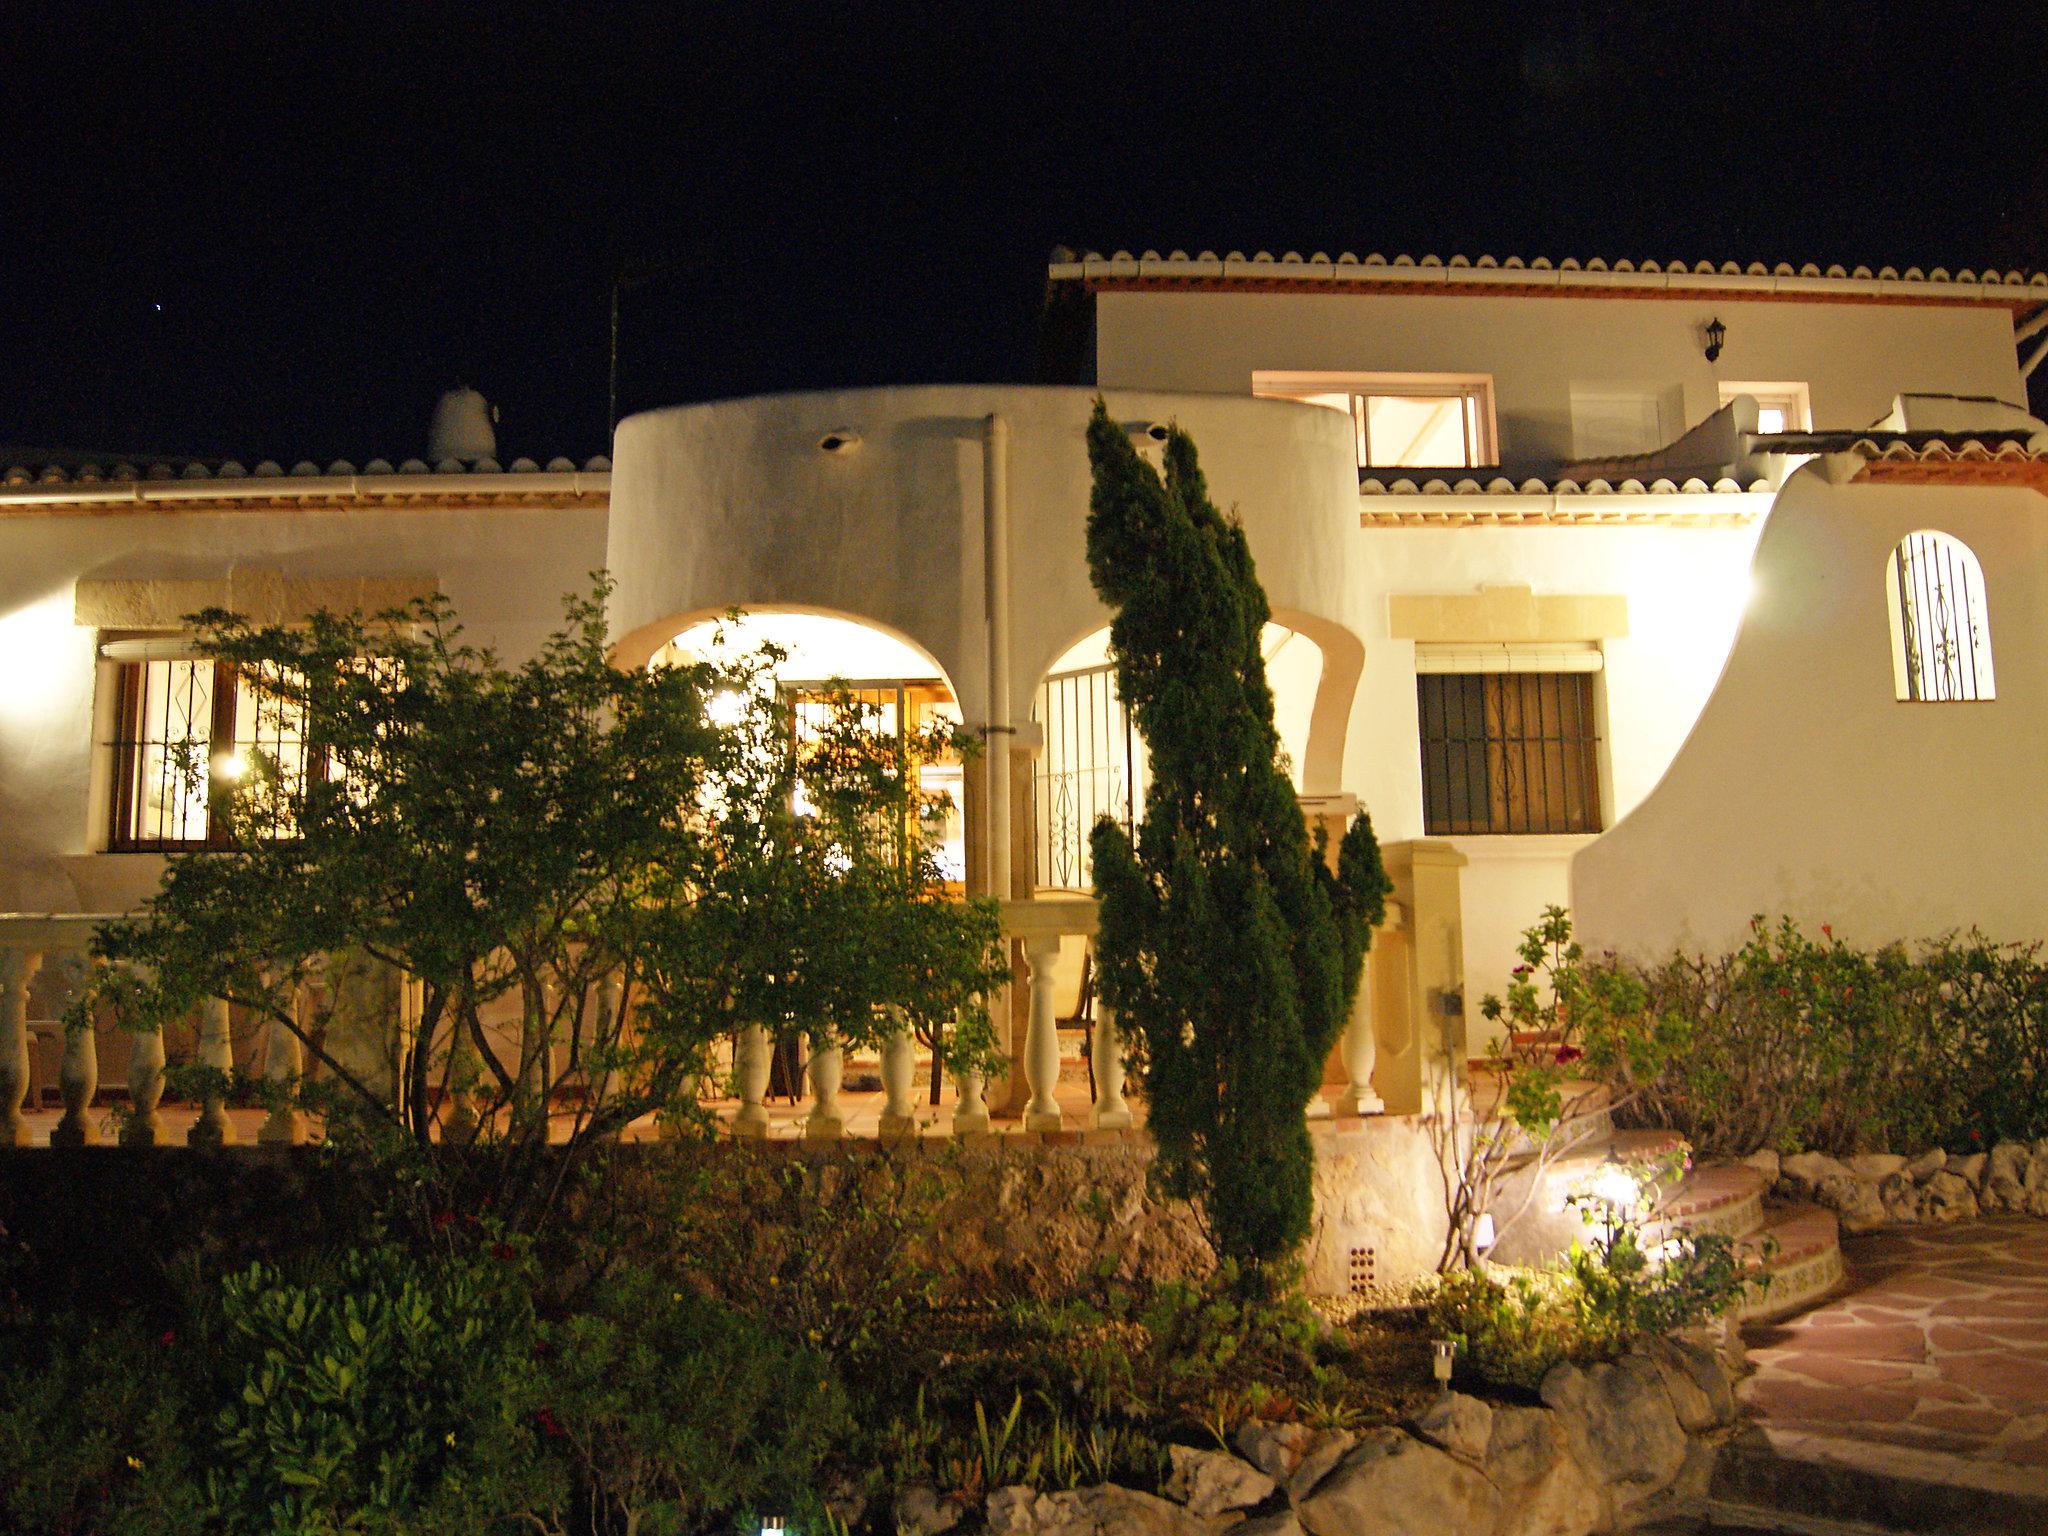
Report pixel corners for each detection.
[1096,293,2025,463]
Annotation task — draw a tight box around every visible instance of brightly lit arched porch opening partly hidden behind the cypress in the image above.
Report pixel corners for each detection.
[1032,625,1356,891]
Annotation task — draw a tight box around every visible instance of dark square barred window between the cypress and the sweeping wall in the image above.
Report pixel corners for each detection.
[1415,672,1599,834]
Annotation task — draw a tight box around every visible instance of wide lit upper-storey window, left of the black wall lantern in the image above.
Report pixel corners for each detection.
[1251,369,1499,469]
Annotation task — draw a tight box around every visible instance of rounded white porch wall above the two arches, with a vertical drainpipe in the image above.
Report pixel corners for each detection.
[608,385,1362,788]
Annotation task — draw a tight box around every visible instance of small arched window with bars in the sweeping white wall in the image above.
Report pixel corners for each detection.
[1884,530,1995,705]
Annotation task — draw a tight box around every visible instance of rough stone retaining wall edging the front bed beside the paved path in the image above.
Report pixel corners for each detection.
[958,1337,1735,1536]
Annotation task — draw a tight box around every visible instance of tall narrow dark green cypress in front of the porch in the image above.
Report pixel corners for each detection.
[1087,401,1391,1270]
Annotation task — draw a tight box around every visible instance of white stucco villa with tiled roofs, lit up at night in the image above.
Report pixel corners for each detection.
[0,252,2048,1204]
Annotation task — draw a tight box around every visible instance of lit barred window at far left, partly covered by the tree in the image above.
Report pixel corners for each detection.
[106,643,305,852]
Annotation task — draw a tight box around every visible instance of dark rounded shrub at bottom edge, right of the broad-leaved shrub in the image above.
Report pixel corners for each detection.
[535,1268,850,1536]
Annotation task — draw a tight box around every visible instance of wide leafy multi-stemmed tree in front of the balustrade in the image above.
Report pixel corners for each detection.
[74,584,1006,1196]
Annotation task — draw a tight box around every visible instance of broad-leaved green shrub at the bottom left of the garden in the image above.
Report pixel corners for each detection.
[209,1241,559,1536]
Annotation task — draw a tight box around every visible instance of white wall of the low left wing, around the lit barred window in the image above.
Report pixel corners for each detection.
[0,506,604,911]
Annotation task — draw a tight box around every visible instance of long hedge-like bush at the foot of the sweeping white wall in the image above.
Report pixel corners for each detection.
[1585,918,2048,1155]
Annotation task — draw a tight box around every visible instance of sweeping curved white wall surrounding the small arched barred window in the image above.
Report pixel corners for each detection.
[1571,459,2048,956]
